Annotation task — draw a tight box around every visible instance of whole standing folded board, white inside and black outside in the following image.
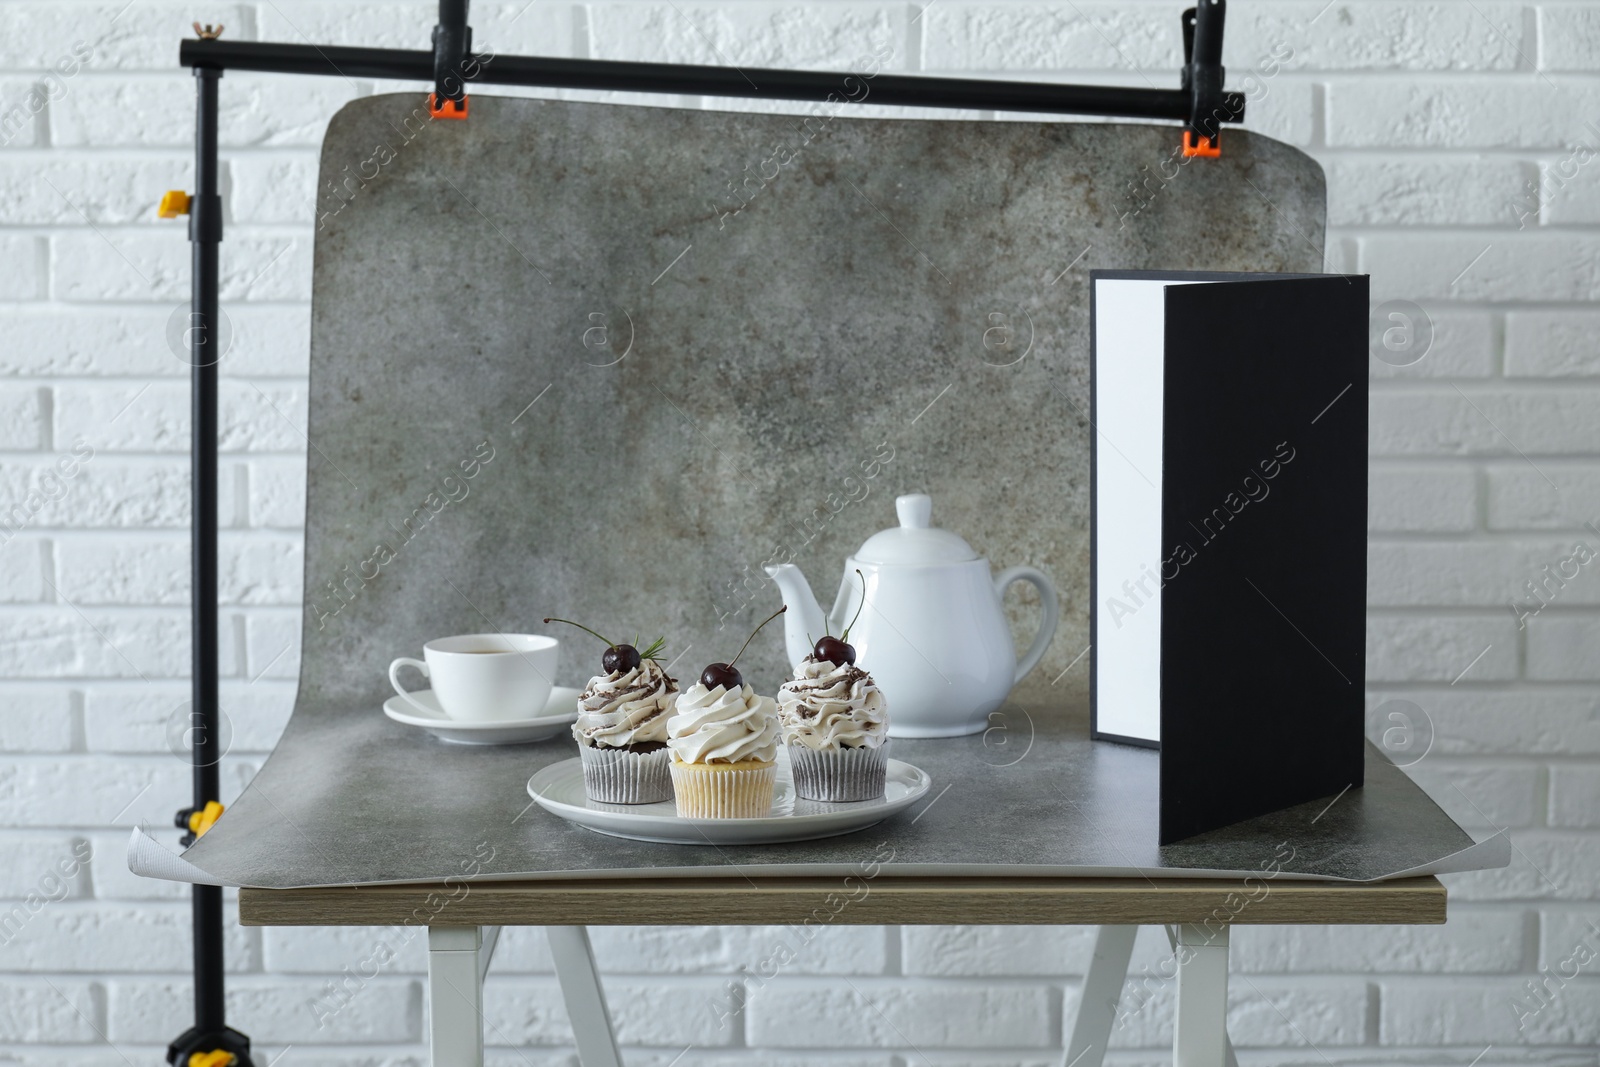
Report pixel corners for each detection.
[1090,270,1368,845]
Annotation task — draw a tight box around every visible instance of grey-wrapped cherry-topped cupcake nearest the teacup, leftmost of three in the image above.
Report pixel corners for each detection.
[546,619,678,805]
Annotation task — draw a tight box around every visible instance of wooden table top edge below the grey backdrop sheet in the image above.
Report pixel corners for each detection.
[238,875,1445,926]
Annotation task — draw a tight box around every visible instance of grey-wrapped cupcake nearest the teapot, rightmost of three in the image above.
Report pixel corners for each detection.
[778,645,890,801]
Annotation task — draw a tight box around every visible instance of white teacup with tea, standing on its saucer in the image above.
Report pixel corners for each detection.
[389,633,562,723]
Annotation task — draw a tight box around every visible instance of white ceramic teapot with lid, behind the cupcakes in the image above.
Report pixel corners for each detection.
[766,493,1061,737]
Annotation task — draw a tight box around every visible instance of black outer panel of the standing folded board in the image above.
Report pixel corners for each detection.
[1160,275,1368,845]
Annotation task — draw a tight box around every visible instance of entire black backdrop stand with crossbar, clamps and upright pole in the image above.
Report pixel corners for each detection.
[160,0,1245,1067]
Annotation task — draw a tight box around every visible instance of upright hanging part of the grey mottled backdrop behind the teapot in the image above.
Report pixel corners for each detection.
[301,94,1325,704]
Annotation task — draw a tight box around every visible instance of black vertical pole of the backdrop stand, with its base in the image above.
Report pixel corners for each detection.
[166,66,250,1067]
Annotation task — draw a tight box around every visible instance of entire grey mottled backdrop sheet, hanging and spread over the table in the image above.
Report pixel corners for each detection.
[168,94,1491,886]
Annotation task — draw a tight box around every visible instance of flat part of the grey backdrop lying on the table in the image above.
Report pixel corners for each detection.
[182,704,1478,888]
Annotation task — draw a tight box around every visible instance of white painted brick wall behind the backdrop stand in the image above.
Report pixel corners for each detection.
[0,0,1600,1067]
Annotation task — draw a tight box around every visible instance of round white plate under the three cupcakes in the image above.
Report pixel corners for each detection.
[528,753,933,845]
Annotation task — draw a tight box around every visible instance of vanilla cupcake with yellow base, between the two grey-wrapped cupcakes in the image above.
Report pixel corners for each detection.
[667,683,779,819]
